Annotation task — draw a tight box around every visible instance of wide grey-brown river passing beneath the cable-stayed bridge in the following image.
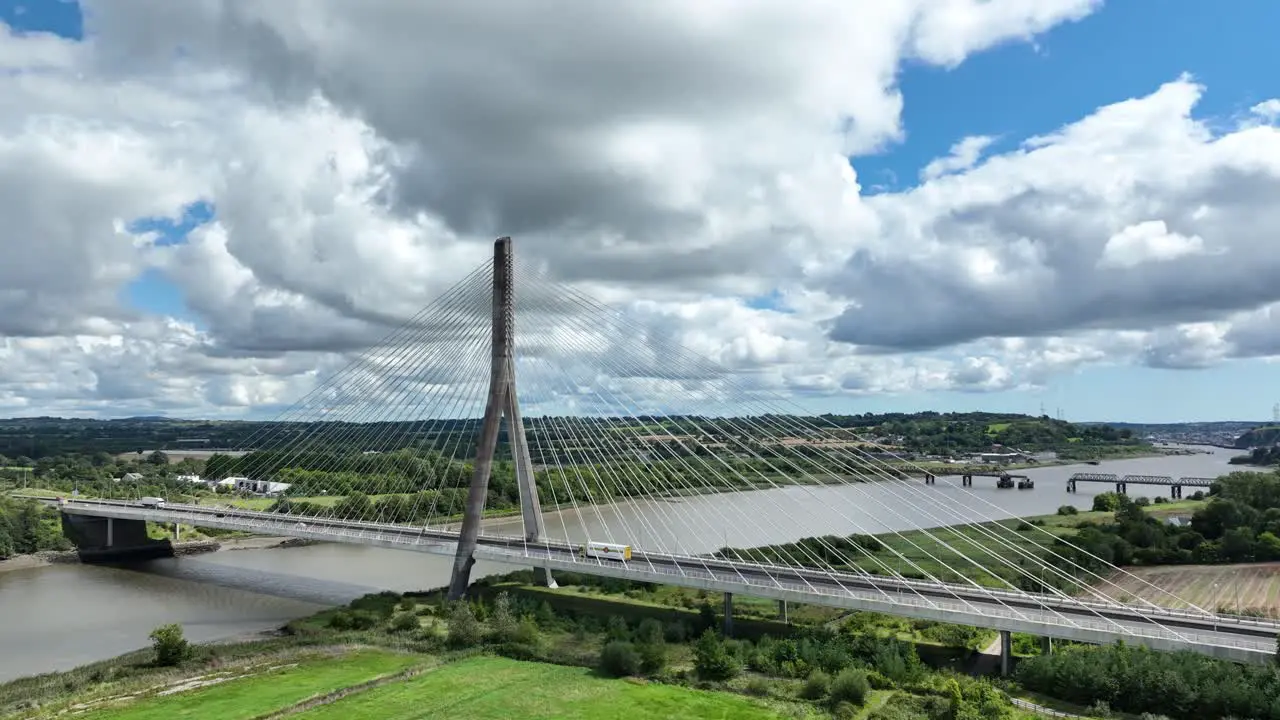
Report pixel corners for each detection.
[0,448,1235,682]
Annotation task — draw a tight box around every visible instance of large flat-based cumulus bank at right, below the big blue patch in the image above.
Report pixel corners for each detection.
[827,77,1280,350]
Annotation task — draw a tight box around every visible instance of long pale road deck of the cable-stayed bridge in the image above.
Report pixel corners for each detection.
[38,498,1280,664]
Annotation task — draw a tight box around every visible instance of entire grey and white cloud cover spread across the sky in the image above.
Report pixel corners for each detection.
[0,0,1280,415]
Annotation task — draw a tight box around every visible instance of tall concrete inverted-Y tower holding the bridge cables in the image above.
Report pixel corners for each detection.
[449,237,552,600]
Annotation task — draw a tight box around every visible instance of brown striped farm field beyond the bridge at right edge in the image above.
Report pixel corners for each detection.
[1098,562,1280,618]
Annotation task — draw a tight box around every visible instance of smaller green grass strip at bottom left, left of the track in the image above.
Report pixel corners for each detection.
[86,651,426,720]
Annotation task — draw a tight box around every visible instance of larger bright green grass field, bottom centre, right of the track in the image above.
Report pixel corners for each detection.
[296,657,781,720]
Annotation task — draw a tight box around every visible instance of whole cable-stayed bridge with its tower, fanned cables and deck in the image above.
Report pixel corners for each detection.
[49,238,1280,662]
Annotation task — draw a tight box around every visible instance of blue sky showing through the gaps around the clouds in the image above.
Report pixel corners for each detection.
[0,0,1280,421]
